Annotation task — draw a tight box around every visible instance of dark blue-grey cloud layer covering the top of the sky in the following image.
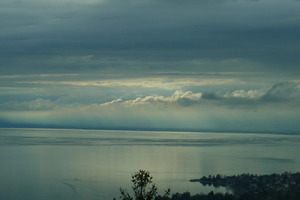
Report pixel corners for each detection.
[0,0,300,74]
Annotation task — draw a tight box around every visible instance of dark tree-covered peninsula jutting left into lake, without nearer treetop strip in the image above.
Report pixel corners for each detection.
[190,172,300,199]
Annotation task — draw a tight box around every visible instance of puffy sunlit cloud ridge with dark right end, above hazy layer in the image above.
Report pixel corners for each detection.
[101,83,300,107]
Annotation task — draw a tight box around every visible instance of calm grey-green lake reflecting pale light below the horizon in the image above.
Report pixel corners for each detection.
[0,129,300,200]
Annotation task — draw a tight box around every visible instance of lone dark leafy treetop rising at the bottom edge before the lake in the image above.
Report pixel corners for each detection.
[120,170,170,200]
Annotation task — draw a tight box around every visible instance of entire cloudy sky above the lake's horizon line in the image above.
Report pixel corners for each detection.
[0,0,300,133]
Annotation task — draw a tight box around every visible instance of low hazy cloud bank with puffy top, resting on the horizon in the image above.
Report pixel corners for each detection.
[0,82,300,133]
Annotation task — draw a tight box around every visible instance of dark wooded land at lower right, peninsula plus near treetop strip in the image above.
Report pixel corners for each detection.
[178,172,300,200]
